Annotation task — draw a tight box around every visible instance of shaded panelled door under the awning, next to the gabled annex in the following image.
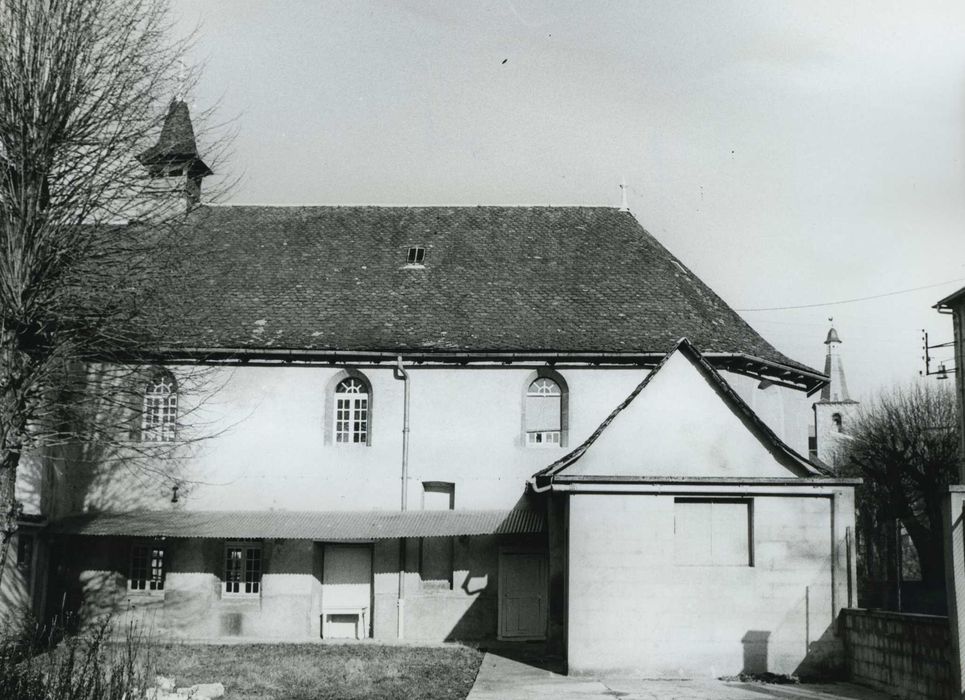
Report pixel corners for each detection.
[499,550,547,639]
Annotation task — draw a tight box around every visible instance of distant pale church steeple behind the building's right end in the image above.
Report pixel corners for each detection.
[809,328,859,469]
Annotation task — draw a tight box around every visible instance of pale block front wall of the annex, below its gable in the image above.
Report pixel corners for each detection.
[567,494,840,677]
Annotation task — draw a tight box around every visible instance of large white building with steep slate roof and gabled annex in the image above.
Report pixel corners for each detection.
[1,102,854,675]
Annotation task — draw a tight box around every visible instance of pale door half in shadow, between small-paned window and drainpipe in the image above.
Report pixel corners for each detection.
[322,544,372,639]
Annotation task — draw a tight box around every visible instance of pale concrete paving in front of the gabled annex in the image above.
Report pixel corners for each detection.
[467,653,888,700]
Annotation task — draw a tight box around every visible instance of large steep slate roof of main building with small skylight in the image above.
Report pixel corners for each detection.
[151,206,820,377]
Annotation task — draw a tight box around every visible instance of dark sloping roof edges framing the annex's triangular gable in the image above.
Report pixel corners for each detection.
[531,338,826,488]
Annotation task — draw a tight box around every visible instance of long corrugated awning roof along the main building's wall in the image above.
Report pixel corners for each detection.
[50,508,546,541]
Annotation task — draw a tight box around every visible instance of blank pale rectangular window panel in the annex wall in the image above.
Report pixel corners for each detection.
[674,498,754,566]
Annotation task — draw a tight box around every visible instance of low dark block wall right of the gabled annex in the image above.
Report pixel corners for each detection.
[840,609,954,700]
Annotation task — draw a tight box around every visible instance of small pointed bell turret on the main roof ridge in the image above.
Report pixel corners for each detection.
[137,96,212,210]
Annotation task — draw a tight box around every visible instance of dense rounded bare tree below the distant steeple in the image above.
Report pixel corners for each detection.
[843,383,961,604]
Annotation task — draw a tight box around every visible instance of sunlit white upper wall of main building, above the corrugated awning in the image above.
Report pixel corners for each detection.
[49,366,805,512]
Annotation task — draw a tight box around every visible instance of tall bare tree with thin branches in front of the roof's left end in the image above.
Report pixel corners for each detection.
[0,0,228,577]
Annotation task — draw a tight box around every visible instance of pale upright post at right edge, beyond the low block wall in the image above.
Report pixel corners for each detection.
[942,484,965,699]
